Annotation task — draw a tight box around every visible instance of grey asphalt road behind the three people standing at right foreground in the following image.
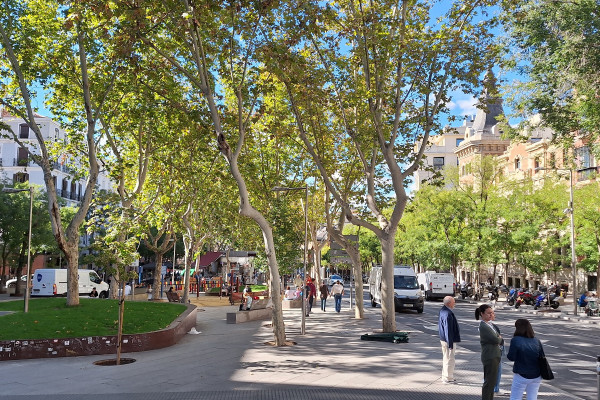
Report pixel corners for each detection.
[386,293,600,400]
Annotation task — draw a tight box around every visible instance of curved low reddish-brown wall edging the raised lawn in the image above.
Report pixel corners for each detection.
[0,304,198,361]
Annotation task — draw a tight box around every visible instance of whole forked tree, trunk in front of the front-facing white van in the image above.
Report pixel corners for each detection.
[264,1,502,332]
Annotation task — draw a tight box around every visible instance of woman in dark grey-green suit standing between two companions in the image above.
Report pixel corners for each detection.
[475,304,504,400]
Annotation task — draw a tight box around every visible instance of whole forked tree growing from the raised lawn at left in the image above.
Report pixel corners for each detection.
[0,0,129,306]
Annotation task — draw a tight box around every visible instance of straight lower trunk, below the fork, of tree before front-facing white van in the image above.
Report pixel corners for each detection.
[379,233,396,332]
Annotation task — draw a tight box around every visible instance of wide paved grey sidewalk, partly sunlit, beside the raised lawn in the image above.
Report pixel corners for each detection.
[0,297,578,400]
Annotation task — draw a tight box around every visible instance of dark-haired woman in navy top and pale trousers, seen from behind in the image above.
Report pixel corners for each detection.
[507,318,546,400]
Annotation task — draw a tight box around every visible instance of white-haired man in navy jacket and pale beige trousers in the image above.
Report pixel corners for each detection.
[438,296,460,383]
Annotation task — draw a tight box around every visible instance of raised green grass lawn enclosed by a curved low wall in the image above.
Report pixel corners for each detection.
[0,297,186,340]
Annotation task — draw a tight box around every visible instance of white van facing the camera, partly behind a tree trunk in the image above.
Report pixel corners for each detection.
[369,265,425,314]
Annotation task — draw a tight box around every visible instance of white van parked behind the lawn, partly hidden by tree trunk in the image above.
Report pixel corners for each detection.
[31,269,108,298]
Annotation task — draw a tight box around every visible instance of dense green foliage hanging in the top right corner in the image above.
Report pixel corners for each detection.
[503,0,600,154]
